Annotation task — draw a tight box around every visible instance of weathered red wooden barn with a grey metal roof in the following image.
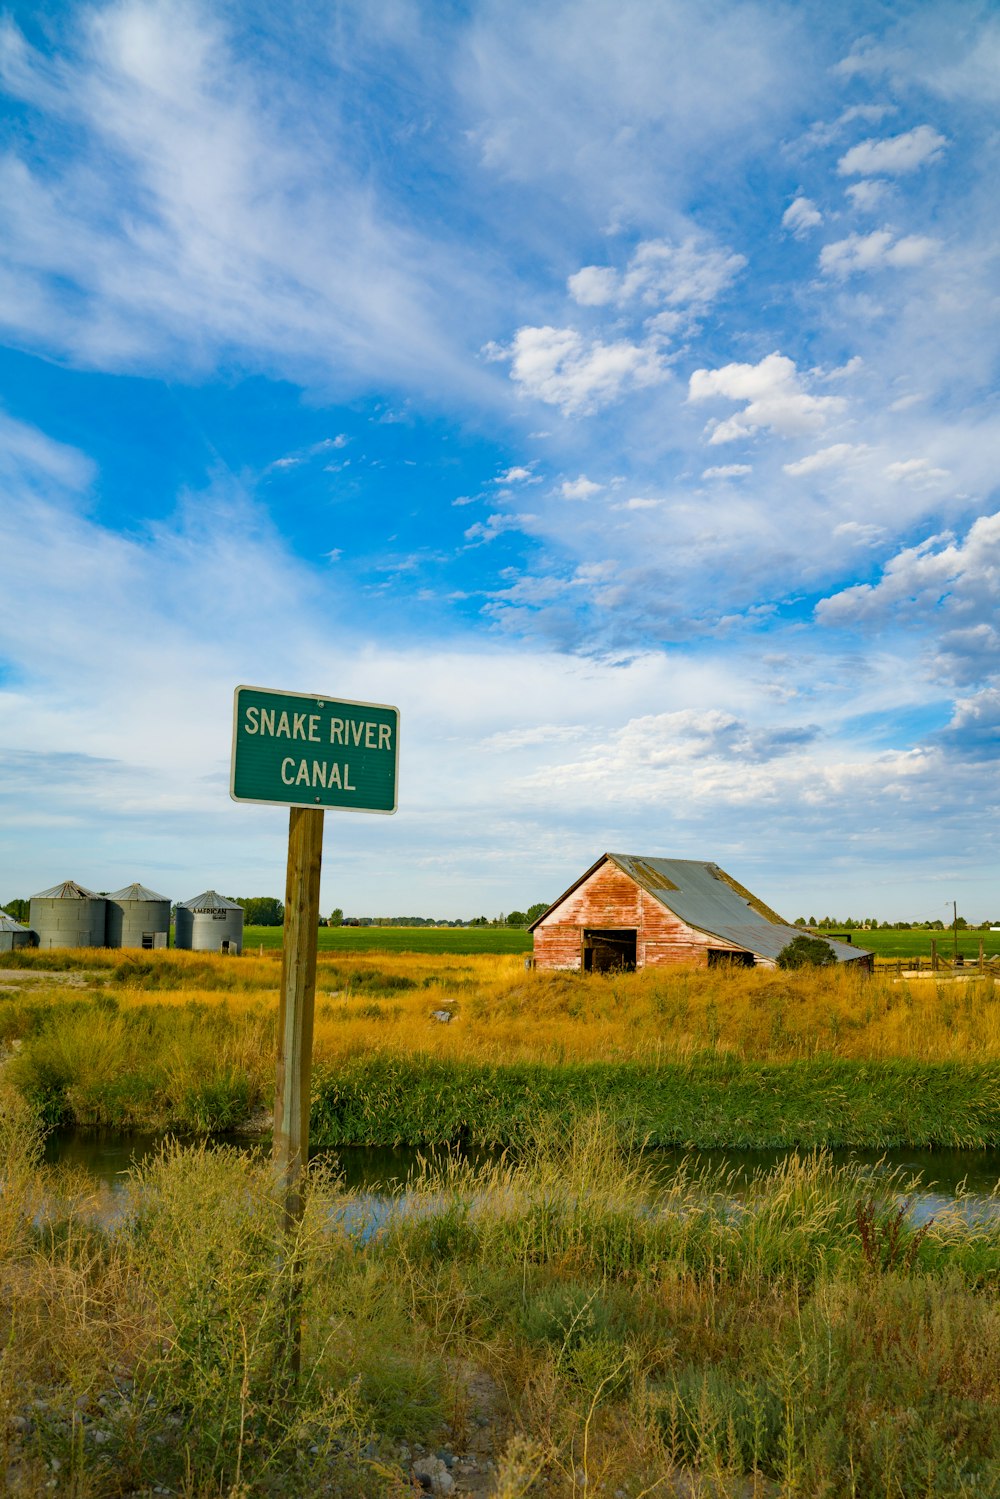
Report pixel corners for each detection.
[529,853,873,973]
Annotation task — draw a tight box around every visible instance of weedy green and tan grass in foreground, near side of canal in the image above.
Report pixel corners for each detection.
[0,1105,1000,1499]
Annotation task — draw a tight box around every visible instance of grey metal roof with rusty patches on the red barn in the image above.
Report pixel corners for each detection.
[529,853,868,962]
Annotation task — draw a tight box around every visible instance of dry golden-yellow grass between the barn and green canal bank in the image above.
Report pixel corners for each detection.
[11,952,1000,1064]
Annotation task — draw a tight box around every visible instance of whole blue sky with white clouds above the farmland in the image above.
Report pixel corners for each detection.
[0,0,1000,919]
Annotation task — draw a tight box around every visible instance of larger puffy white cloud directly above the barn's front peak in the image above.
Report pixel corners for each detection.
[505,327,669,415]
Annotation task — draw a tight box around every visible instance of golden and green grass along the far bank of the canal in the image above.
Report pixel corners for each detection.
[0,952,1000,1148]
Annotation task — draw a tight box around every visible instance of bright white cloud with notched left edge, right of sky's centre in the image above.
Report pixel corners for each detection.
[688,354,846,445]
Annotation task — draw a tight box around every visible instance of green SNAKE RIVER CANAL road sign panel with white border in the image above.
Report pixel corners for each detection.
[229,687,399,812]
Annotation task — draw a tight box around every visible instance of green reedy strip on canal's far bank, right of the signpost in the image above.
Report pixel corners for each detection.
[312,1052,1000,1150]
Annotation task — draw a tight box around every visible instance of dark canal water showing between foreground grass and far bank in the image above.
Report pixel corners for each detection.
[45,1130,1000,1216]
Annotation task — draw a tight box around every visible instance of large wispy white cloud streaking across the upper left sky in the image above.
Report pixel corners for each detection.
[0,0,493,398]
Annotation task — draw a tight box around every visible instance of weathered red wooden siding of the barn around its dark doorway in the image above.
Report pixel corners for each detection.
[535,859,744,968]
